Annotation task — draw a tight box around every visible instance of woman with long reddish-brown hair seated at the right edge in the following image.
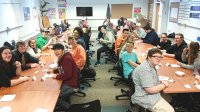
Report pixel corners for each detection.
[178,42,200,69]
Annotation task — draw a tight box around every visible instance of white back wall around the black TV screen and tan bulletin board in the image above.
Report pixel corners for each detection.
[46,0,148,29]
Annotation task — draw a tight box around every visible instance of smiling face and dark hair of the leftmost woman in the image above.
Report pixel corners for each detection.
[0,46,12,63]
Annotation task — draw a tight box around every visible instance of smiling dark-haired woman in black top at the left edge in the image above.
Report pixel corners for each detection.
[0,46,29,87]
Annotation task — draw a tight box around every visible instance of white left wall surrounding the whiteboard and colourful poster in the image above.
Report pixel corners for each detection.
[0,0,39,46]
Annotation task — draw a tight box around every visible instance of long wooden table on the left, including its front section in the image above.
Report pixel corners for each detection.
[0,50,62,112]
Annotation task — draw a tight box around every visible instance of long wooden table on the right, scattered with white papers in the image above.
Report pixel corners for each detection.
[135,42,200,93]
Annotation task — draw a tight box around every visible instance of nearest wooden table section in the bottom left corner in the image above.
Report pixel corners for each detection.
[0,91,59,112]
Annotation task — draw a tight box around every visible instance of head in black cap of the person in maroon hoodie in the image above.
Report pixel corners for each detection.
[52,43,65,59]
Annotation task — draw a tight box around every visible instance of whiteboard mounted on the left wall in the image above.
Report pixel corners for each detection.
[0,3,23,32]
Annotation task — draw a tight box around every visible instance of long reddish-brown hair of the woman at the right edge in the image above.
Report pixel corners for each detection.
[188,41,199,64]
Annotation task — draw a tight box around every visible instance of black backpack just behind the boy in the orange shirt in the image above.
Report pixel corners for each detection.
[81,67,96,78]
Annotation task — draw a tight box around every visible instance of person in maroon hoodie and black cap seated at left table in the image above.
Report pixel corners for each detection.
[47,43,79,111]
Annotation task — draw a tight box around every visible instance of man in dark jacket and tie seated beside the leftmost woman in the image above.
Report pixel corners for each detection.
[13,41,42,70]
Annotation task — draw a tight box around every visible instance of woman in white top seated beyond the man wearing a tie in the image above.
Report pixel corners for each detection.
[26,39,41,58]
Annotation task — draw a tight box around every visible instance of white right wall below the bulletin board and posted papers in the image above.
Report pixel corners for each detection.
[167,0,200,42]
